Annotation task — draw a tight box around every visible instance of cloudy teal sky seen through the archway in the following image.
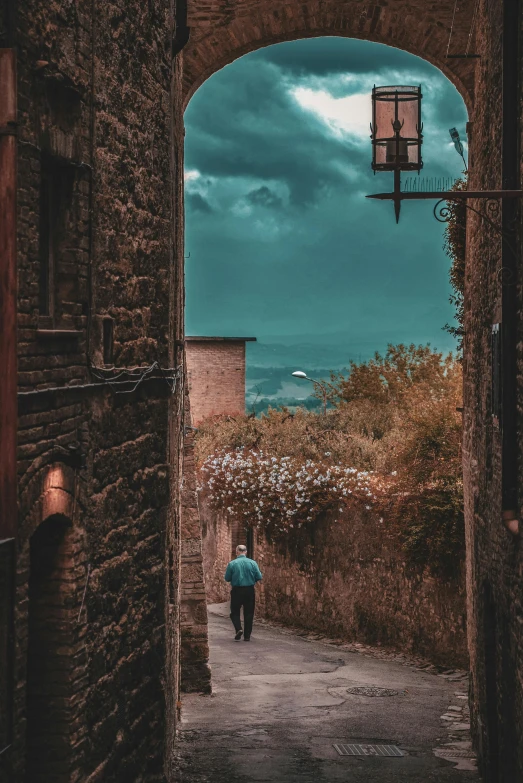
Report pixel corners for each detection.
[185,38,467,362]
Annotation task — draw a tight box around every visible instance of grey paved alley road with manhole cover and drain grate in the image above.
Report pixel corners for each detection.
[180,606,478,783]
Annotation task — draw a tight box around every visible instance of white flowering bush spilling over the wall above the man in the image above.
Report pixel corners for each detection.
[201,449,374,532]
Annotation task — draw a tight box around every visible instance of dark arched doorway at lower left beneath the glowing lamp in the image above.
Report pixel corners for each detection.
[26,516,75,783]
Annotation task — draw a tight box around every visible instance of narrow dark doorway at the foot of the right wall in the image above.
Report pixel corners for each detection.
[483,582,499,783]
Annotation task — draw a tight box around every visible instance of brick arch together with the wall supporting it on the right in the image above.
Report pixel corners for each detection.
[177,6,523,777]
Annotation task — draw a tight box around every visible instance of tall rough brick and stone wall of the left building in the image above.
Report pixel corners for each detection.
[6,0,183,783]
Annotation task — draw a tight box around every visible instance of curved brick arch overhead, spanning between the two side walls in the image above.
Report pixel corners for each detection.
[183,0,475,112]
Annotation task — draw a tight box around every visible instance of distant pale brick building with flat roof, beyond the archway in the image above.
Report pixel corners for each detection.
[185,337,252,425]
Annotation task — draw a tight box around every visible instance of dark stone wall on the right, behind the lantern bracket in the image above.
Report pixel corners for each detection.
[463,2,523,783]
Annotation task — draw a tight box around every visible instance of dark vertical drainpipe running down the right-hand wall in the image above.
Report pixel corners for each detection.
[501,0,520,533]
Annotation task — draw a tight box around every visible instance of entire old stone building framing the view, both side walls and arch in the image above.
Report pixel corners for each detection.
[0,0,523,783]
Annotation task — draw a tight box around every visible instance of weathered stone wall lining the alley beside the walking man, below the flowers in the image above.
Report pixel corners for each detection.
[200,497,468,668]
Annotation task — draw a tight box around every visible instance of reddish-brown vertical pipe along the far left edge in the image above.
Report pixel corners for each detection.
[0,49,17,539]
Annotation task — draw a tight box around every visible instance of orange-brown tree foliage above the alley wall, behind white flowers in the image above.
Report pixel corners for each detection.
[196,345,465,574]
